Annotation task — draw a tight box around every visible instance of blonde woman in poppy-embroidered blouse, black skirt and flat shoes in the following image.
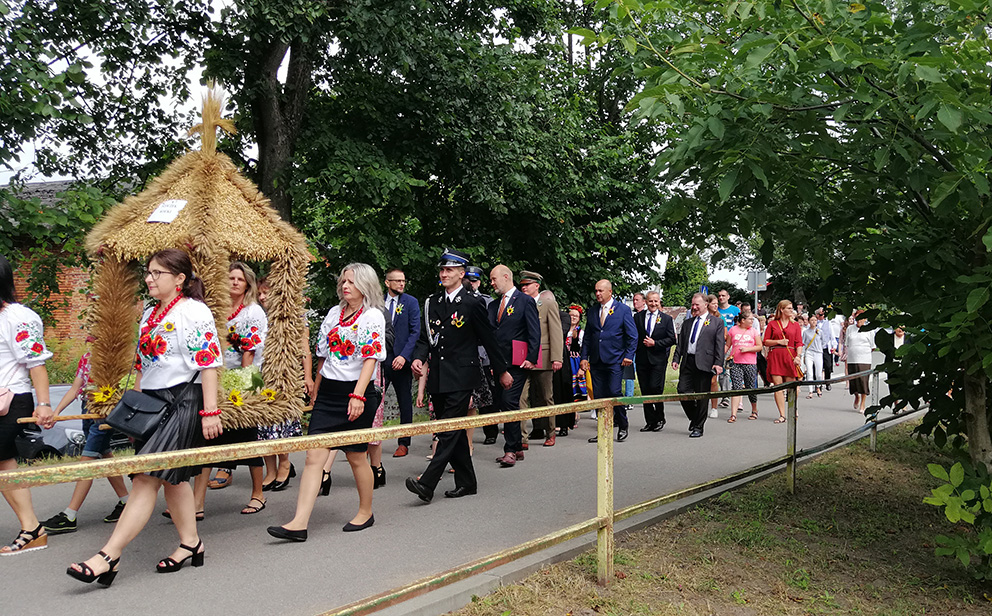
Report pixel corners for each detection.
[268,263,386,541]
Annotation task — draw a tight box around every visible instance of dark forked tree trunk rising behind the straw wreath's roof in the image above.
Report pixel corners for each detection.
[245,41,313,222]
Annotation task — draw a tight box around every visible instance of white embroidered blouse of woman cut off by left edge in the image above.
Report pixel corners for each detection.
[0,304,52,394]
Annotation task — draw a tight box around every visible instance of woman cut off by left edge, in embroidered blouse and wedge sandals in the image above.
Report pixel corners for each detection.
[0,255,55,556]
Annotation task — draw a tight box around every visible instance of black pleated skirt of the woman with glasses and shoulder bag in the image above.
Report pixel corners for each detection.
[134,383,207,485]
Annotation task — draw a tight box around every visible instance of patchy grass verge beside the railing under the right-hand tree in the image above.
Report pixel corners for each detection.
[454,424,992,616]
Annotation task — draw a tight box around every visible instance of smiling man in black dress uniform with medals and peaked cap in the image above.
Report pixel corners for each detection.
[406,250,512,503]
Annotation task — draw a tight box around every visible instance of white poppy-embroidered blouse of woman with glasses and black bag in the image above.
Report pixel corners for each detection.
[136,298,221,389]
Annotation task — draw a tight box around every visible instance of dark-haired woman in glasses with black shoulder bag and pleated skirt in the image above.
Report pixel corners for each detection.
[66,248,223,586]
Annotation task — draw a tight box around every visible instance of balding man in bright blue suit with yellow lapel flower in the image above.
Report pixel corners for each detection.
[579,280,637,443]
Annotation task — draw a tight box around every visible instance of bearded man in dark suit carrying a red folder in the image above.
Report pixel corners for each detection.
[486,265,541,472]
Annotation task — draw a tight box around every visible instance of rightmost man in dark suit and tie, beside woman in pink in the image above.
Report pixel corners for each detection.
[672,293,726,438]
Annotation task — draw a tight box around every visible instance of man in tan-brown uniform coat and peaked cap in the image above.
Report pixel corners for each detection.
[520,270,565,447]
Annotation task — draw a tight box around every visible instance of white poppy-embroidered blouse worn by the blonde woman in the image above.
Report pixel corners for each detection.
[317,306,386,382]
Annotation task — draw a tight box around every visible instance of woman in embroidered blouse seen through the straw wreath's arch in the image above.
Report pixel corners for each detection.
[194,261,268,520]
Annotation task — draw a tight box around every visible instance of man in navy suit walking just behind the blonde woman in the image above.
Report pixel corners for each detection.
[382,267,420,458]
